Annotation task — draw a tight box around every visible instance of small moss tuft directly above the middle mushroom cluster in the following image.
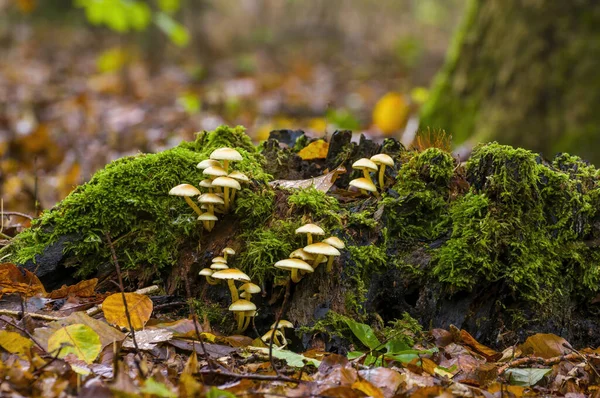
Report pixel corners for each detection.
[288,187,341,228]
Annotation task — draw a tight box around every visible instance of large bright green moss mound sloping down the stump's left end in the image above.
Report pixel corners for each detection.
[5,127,268,278]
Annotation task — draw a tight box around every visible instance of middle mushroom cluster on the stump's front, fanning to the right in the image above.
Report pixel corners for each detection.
[275,224,345,283]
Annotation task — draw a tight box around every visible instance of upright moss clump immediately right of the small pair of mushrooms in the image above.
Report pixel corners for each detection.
[383,148,455,244]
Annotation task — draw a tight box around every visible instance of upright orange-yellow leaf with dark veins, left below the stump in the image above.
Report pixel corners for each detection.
[102,293,153,330]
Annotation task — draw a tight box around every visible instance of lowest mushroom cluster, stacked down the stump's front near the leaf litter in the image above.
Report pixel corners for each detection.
[200,247,261,333]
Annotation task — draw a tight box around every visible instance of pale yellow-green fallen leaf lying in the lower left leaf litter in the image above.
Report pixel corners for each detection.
[48,323,102,363]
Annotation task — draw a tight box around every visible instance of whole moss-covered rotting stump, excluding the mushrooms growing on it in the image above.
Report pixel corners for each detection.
[0,127,600,346]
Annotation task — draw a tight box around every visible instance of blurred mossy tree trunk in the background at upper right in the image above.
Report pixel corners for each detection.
[422,0,600,162]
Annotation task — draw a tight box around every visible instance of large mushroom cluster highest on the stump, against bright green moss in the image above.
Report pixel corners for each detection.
[169,148,250,231]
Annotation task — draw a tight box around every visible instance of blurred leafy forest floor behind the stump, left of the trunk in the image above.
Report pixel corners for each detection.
[0,0,466,213]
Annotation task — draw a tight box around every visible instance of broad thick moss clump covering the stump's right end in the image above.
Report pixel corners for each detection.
[433,143,600,303]
